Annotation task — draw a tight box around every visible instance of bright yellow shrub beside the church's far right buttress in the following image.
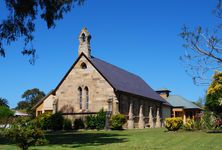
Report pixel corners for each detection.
[165,117,183,131]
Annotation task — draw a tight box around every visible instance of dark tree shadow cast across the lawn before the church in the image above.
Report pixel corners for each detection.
[46,132,127,148]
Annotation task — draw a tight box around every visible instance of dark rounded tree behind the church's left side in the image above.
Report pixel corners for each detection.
[17,88,45,116]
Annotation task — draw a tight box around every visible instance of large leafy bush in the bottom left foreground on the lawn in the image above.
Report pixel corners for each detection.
[3,119,47,150]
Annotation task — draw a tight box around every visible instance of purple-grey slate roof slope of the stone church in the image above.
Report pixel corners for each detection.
[90,57,165,102]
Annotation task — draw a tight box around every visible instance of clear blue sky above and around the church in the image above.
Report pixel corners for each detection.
[0,0,220,107]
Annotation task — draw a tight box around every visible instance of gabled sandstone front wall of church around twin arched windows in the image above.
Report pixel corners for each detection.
[56,56,115,113]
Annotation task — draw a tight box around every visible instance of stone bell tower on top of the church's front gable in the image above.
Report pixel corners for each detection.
[78,27,91,58]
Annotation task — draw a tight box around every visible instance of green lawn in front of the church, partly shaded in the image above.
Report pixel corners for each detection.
[0,129,222,150]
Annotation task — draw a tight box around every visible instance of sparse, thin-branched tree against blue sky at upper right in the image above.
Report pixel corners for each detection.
[180,0,222,85]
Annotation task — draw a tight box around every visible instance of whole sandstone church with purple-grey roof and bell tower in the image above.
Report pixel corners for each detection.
[34,28,171,129]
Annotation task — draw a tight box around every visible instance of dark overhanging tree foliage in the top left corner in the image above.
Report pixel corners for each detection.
[0,0,85,64]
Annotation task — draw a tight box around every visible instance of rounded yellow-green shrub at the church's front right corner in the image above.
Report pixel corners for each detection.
[111,114,126,130]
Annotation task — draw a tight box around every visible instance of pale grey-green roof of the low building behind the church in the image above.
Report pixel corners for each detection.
[166,95,201,109]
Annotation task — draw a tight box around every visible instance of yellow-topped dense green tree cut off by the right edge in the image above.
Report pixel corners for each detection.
[205,72,222,117]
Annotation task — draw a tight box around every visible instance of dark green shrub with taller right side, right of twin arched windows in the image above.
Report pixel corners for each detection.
[86,109,106,130]
